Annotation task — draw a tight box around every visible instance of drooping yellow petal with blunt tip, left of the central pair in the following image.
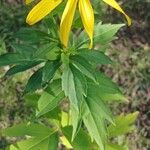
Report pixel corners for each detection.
[60,0,78,47]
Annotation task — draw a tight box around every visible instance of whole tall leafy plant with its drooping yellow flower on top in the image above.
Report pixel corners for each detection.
[0,0,138,150]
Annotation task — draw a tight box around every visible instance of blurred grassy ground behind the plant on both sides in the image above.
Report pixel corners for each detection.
[0,0,150,150]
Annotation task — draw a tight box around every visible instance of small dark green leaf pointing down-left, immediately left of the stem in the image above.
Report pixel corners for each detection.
[42,60,61,84]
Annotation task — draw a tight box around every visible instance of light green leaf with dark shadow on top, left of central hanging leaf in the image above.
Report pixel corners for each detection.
[37,80,65,117]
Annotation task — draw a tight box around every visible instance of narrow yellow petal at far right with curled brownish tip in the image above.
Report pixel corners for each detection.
[103,0,131,26]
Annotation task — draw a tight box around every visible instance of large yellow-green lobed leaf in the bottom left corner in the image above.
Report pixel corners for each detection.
[3,123,58,150]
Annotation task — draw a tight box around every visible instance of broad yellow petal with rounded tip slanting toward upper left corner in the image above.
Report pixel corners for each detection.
[26,0,62,25]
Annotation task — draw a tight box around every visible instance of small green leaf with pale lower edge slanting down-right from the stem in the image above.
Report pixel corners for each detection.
[70,55,96,82]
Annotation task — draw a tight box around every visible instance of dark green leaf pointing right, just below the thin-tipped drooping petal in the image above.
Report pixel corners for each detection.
[79,49,112,65]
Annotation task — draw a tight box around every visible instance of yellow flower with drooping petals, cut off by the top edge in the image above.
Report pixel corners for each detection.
[26,0,131,48]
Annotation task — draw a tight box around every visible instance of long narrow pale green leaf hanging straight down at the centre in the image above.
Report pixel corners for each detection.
[62,58,87,139]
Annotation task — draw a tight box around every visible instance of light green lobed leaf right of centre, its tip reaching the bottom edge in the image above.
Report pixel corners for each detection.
[83,84,113,150]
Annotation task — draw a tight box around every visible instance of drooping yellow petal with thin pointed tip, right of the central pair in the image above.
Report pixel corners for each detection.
[79,0,94,48]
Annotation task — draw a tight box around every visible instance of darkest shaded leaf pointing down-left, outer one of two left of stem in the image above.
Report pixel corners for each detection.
[24,69,42,94]
